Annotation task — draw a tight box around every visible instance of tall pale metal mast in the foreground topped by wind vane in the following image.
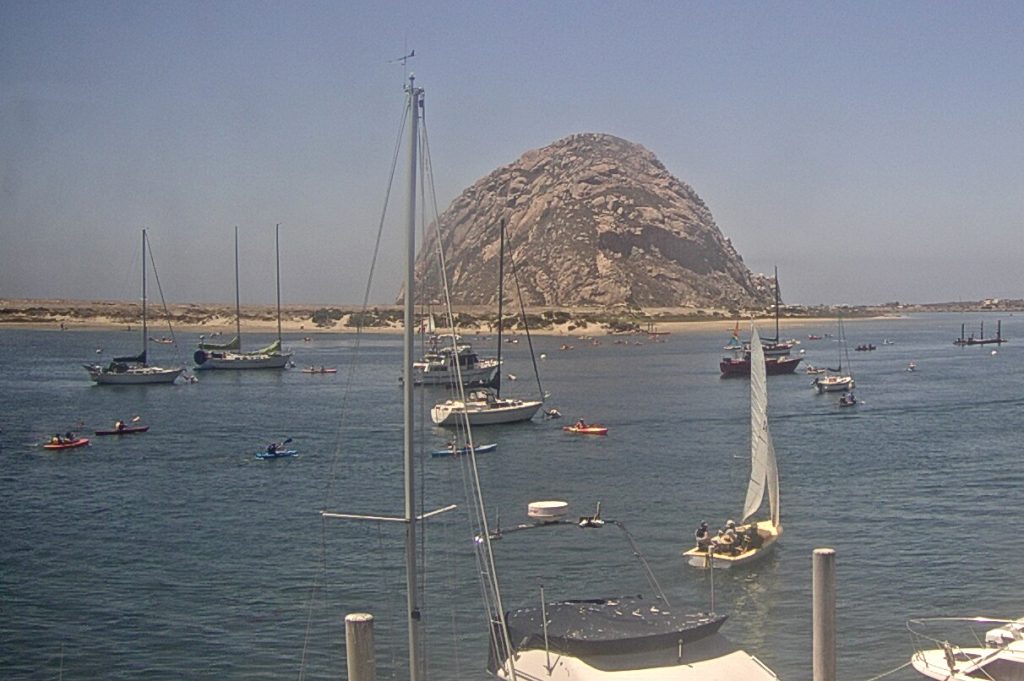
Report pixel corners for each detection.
[401,75,423,681]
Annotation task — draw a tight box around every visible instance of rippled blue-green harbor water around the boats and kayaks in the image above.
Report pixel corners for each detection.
[0,314,1024,681]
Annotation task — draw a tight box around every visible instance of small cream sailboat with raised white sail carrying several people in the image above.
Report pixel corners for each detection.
[683,329,782,567]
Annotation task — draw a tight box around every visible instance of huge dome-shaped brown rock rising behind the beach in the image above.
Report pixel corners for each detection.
[417,133,773,308]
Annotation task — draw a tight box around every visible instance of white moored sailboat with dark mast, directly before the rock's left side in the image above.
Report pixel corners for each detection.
[430,220,544,426]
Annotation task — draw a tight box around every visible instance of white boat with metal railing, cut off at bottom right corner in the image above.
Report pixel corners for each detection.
[907,618,1024,681]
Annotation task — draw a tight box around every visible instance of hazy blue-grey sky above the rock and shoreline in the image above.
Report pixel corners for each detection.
[0,0,1024,304]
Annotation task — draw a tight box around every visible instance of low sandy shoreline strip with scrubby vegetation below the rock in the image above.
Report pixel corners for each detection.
[0,299,1024,336]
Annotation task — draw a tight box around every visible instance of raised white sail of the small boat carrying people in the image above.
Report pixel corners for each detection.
[741,329,778,525]
